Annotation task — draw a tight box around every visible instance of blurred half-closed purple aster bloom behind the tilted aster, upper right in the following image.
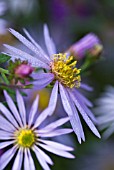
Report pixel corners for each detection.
[67,33,102,60]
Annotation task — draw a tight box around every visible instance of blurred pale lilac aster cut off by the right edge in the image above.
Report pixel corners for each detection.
[94,86,114,138]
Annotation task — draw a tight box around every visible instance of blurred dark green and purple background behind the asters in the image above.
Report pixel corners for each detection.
[0,0,114,170]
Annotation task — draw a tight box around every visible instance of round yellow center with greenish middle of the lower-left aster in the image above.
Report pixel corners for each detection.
[16,128,35,148]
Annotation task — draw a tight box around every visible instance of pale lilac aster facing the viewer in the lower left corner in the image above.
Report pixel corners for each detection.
[0,91,74,170]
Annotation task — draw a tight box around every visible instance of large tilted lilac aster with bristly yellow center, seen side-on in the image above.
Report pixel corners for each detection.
[4,25,100,143]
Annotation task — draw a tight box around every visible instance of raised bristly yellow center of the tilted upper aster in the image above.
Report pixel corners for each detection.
[51,53,81,88]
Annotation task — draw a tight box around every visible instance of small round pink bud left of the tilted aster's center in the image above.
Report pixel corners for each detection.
[15,64,34,78]
